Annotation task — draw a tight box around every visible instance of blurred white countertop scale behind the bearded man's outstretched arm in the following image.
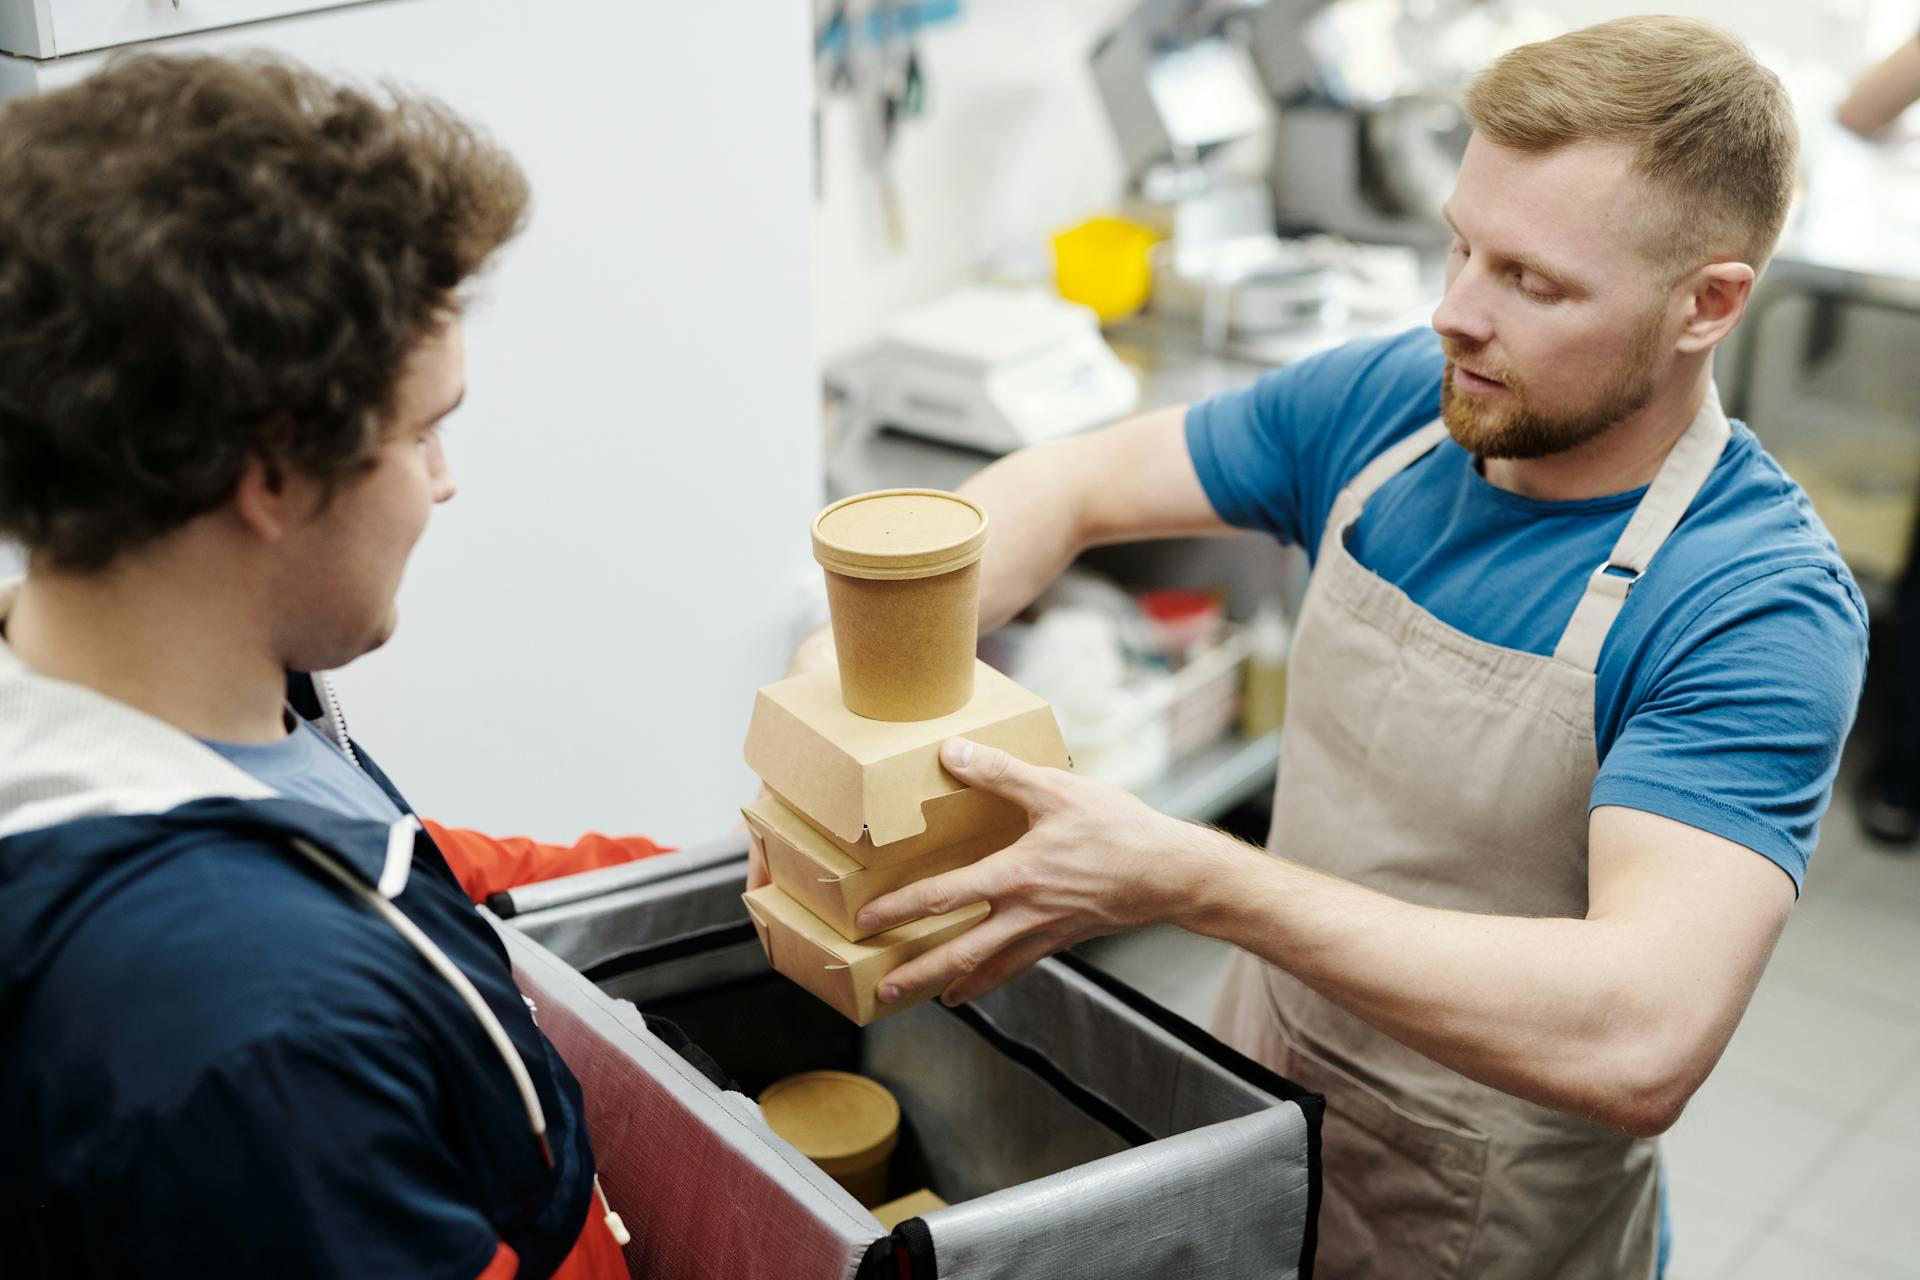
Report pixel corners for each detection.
[868,286,1140,453]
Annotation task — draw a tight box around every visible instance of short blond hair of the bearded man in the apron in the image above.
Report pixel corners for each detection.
[1465,17,1799,273]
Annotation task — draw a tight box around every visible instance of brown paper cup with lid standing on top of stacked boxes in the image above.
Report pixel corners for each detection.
[812,489,987,722]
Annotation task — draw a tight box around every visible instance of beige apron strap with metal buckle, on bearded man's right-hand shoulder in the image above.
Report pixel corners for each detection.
[1553,382,1734,672]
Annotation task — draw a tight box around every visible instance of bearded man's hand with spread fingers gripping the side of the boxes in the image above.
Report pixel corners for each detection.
[860,739,1260,1004]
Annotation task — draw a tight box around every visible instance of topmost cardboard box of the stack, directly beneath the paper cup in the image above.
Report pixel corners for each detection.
[745,662,1073,862]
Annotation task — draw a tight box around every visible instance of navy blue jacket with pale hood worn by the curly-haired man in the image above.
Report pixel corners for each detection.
[0,667,593,1278]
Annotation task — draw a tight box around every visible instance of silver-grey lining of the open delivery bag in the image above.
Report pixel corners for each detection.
[509,856,1319,1280]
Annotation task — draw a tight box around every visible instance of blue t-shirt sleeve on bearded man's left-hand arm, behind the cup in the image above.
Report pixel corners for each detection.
[1187,328,1444,553]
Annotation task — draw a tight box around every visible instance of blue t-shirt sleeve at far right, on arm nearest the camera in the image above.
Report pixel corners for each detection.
[1592,564,1866,890]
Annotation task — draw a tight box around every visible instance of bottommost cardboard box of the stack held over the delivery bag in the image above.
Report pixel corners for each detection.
[741,885,987,1027]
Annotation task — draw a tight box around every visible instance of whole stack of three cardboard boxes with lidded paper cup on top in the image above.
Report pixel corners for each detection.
[743,489,1069,1027]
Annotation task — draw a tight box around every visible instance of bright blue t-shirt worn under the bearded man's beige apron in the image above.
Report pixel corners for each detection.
[1187,330,1866,890]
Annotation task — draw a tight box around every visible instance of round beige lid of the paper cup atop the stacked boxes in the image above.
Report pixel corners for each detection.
[814,489,987,580]
